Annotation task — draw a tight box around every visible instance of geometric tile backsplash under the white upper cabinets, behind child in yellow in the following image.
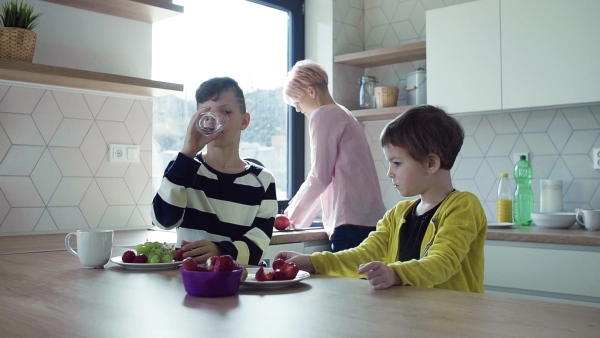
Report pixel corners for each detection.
[365,106,600,220]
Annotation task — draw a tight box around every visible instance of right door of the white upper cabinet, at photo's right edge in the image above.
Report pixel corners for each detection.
[502,0,600,109]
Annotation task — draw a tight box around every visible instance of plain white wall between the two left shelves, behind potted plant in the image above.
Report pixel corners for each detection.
[0,0,152,80]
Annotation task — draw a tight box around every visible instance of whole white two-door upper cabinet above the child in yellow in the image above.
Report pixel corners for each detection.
[426,0,600,113]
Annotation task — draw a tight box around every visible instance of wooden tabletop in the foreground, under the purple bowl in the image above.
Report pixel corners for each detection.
[0,251,600,338]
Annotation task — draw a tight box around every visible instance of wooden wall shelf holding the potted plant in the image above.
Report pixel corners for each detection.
[0,60,183,97]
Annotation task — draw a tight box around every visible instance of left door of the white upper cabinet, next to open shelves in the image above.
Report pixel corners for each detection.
[425,0,502,113]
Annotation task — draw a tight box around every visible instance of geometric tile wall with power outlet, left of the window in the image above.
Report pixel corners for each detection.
[0,85,152,235]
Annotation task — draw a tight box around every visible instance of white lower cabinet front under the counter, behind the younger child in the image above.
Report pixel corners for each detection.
[484,240,600,307]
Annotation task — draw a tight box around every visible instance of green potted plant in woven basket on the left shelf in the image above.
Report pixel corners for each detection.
[0,0,41,62]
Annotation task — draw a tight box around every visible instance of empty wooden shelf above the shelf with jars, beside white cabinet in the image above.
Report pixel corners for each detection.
[333,41,426,68]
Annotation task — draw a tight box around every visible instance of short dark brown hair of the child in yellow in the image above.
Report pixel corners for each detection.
[380,105,465,170]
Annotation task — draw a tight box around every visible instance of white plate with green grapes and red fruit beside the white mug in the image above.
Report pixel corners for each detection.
[110,242,182,270]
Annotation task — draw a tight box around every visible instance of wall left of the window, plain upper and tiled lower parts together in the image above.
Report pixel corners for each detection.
[0,0,152,236]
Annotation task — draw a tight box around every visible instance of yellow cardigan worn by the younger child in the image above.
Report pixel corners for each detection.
[310,191,487,293]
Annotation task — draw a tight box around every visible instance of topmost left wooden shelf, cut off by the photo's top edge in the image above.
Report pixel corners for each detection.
[42,0,183,23]
